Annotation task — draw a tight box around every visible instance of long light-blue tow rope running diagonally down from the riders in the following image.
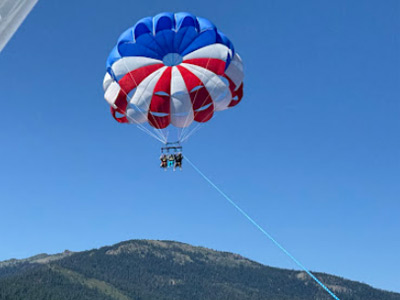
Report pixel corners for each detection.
[185,155,340,300]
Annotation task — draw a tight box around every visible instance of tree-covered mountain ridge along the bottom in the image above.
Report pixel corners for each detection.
[0,240,400,300]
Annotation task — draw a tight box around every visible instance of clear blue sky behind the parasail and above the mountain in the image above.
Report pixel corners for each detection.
[0,0,400,292]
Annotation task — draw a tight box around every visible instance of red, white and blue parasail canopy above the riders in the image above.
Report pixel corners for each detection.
[103,13,243,142]
